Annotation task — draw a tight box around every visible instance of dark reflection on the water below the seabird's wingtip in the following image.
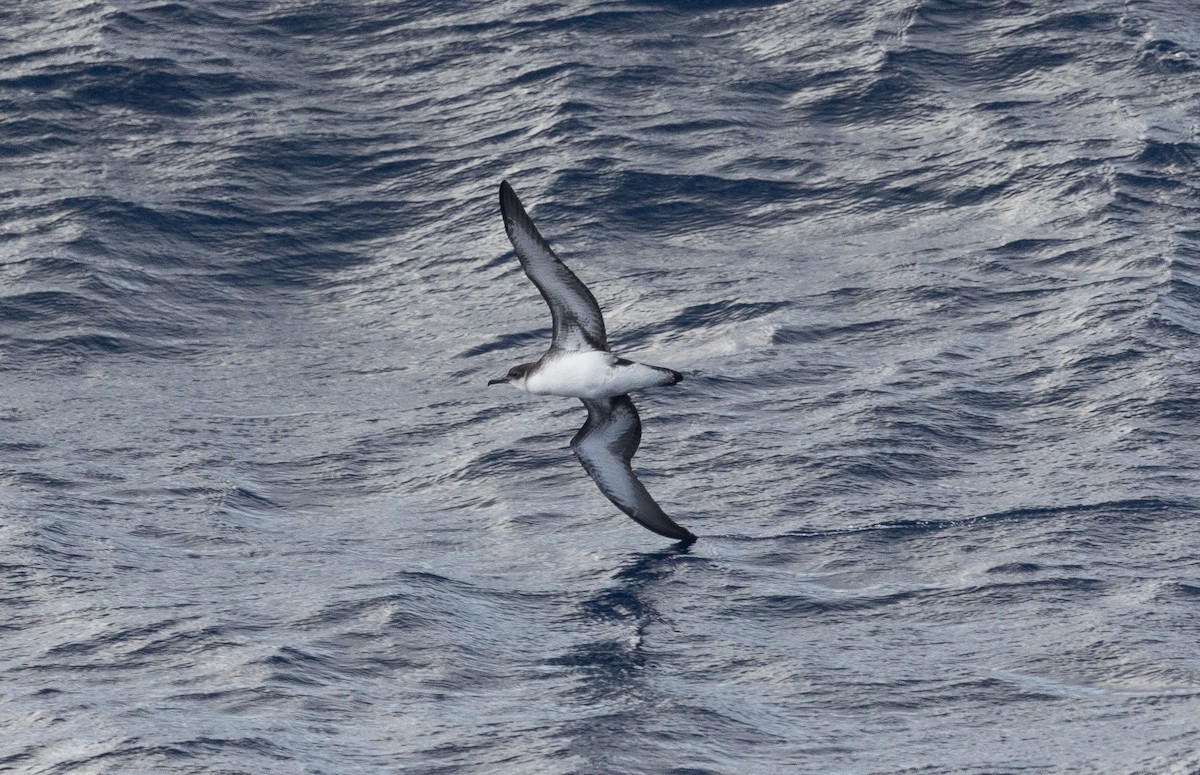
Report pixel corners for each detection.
[548,541,692,702]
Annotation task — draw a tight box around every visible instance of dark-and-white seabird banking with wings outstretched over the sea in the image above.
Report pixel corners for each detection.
[487,180,696,541]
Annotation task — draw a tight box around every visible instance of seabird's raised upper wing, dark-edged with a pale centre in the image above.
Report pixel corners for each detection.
[500,180,608,350]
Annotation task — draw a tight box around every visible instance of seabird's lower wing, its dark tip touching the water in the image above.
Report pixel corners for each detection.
[571,396,696,541]
